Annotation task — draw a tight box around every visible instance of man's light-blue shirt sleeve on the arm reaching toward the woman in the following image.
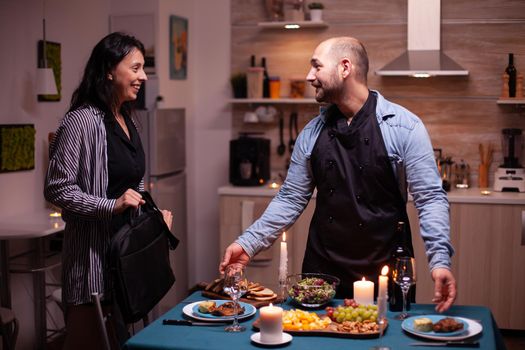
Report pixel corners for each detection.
[236,126,315,257]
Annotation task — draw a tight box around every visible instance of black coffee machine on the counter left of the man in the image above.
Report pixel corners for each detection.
[230,134,270,186]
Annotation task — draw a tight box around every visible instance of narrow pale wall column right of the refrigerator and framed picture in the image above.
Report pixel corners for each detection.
[188,0,231,285]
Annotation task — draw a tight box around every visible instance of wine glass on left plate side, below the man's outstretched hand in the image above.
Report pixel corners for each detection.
[223,264,248,332]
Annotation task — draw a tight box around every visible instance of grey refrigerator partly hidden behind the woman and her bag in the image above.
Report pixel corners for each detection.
[136,109,188,318]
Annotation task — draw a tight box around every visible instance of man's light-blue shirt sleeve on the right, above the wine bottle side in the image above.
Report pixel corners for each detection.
[405,120,454,271]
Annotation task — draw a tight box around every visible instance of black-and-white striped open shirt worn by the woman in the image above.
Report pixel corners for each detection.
[44,106,144,305]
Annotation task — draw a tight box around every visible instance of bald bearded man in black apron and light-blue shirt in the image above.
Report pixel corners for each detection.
[219,37,456,312]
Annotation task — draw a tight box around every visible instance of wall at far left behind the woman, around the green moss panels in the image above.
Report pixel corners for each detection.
[0,0,109,350]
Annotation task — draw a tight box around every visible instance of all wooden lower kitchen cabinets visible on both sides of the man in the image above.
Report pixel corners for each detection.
[219,187,525,330]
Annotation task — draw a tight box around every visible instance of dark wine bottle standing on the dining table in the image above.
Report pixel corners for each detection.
[388,221,410,311]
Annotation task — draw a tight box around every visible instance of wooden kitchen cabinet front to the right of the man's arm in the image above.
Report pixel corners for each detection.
[451,203,525,329]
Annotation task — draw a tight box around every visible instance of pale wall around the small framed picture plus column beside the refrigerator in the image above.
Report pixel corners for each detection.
[155,0,231,287]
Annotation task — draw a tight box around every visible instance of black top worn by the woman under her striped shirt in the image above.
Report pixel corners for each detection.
[104,116,146,199]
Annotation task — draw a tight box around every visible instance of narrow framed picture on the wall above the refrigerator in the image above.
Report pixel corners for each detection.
[169,16,188,80]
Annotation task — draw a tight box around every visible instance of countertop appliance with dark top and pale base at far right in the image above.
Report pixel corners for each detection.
[494,129,525,192]
